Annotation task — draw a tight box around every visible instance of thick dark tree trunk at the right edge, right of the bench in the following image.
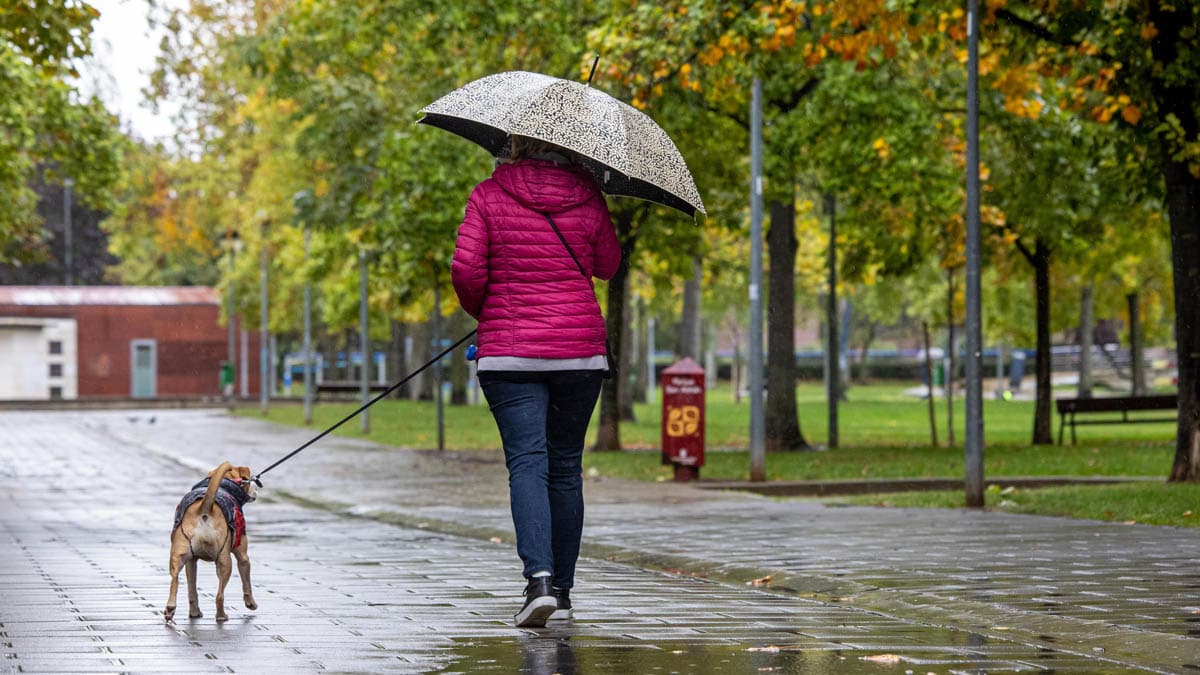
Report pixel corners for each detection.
[1147,2,1200,482]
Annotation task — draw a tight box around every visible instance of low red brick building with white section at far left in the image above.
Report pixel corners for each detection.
[0,286,259,399]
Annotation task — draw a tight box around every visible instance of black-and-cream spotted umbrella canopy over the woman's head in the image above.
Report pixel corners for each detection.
[419,71,707,215]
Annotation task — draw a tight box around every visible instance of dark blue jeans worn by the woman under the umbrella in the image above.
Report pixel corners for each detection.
[479,370,604,589]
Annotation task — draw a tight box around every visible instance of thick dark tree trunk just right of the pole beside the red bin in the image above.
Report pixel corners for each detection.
[764,201,811,452]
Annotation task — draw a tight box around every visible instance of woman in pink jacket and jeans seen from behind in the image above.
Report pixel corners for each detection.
[450,136,620,627]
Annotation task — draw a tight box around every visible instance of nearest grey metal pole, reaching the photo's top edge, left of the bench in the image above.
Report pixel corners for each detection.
[965,0,983,507]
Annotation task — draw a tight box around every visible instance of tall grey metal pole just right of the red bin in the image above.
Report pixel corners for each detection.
[746,78,767,480]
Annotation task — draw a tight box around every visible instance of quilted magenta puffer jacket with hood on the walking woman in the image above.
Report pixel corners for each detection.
[450,160,620,359]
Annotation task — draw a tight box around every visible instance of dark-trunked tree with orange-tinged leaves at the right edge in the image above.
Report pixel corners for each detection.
[995,0,1200,482]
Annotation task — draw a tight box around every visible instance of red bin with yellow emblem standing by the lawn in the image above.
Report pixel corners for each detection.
[662,358,704,482]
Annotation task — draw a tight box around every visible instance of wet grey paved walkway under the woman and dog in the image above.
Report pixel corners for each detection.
[0,411,1200,674]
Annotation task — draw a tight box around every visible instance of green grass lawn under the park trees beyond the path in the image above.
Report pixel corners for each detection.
[239,384,1200,525]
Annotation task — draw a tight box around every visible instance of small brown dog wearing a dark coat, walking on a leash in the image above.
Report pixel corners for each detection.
[163,461,258,621]
